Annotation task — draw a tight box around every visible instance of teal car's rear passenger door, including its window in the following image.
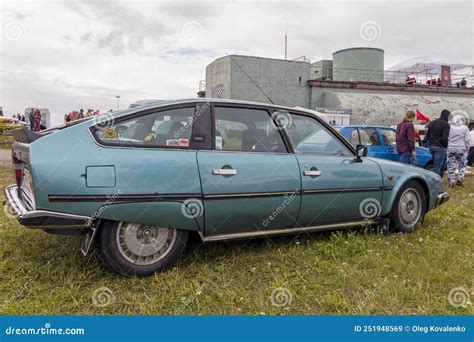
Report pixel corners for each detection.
[197,105,301,235]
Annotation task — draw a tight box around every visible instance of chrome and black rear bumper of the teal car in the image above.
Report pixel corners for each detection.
[5,185,92,229]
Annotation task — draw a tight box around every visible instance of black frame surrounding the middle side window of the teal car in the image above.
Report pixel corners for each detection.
[211,102,293,155]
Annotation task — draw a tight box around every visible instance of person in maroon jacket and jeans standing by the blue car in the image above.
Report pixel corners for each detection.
[396,110,416,165]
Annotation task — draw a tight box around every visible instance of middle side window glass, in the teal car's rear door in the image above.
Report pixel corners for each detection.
[214,107,286,152]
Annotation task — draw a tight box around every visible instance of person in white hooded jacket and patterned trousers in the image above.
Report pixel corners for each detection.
[447,115,470,187]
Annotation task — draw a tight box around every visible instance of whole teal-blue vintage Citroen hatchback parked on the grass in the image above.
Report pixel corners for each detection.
[5,99,449,276]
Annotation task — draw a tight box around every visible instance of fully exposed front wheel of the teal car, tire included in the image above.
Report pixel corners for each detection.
[391,181,426,233]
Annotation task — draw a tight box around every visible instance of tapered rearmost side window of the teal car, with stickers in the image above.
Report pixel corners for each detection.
[95,107,194,148]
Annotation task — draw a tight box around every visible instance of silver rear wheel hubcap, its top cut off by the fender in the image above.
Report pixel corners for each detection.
[116,222,176,265]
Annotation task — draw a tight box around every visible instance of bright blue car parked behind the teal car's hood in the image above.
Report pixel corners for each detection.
[336,125,433,170]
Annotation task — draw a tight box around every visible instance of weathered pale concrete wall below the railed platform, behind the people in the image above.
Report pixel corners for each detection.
[311,88,474,125]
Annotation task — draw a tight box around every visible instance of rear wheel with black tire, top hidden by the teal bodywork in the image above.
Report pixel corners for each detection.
[97,221,188,277]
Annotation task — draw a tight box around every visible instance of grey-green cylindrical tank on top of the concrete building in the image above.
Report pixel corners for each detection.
[332,47,384,82]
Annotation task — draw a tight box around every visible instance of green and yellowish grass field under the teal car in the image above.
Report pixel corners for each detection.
[0,160,474,315]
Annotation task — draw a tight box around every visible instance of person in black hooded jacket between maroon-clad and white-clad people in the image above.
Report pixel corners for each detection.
[423,109,451,177]
